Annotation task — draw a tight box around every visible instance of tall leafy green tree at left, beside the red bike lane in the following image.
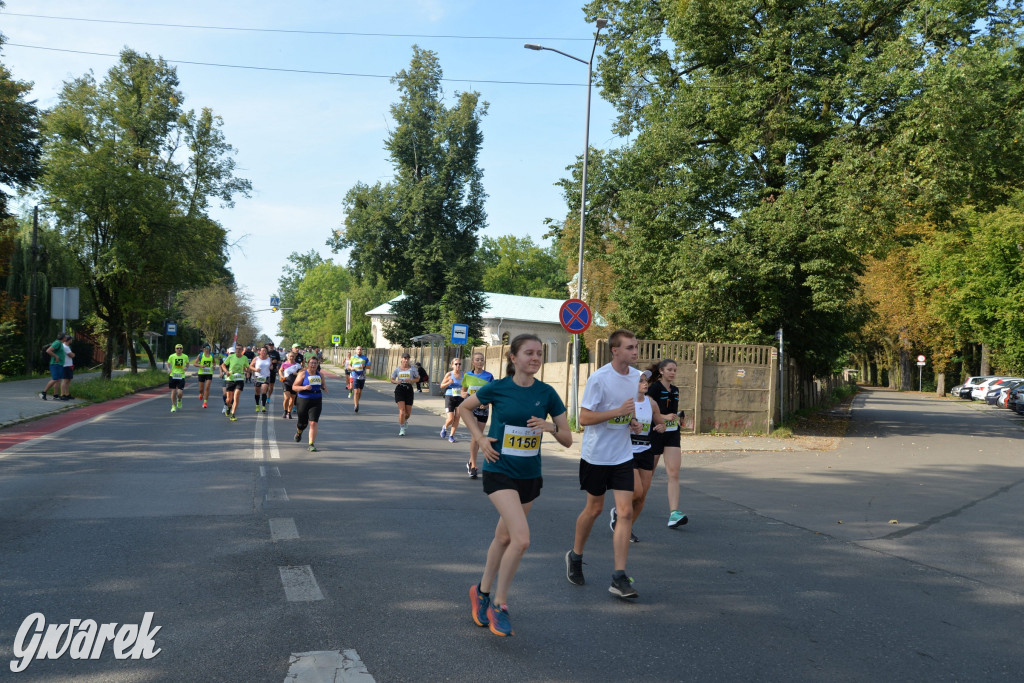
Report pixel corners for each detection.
[42,49,249,376]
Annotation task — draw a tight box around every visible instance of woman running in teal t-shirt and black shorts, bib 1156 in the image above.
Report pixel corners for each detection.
[459,335,572,636]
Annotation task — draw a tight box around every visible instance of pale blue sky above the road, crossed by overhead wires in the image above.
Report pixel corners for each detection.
[0,0,620,340]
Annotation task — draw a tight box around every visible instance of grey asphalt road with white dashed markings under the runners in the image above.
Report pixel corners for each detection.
[0,386,1024,681]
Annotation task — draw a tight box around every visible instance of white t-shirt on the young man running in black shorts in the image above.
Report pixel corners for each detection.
[580,362,640,465]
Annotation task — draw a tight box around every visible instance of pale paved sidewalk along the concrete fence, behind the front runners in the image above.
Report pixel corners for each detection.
[324,364,806,458]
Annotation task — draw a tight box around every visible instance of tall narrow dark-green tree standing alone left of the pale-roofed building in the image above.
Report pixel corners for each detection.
[328,46,487,343]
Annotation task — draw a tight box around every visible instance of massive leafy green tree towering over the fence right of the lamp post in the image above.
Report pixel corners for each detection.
[577,0,1021,372]
